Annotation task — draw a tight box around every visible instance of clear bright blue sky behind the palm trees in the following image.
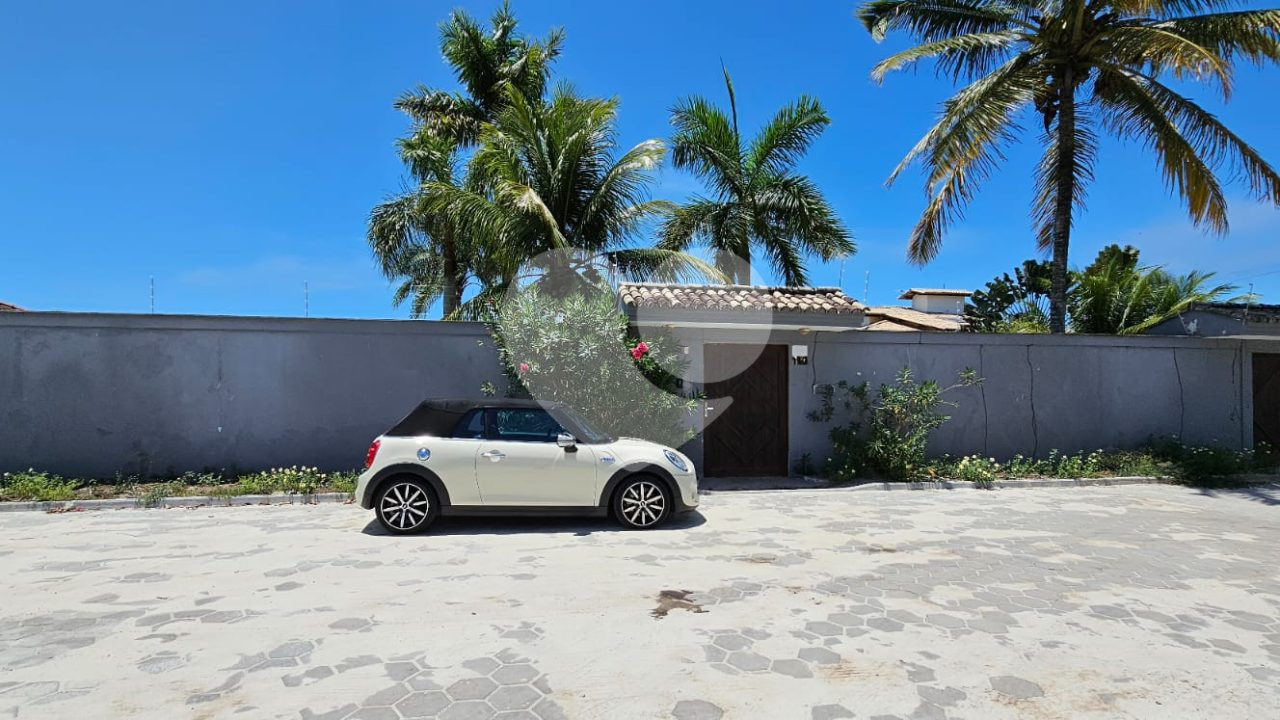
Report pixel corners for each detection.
[0,0,1280,318]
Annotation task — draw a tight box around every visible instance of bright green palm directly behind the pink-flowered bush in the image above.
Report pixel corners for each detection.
[422,86,718,316]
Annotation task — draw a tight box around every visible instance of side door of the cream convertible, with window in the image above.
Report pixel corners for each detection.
[476,407,596,507]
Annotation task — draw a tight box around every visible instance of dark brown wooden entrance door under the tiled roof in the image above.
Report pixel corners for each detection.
[703,345,788,477]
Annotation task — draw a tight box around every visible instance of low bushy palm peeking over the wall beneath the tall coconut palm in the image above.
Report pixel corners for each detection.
[1069,245,1244,334]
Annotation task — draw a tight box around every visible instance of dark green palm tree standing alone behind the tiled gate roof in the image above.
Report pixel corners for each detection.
[660,69,855,286]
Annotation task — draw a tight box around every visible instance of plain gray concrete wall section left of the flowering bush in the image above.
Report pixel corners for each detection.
[0,313,502,477]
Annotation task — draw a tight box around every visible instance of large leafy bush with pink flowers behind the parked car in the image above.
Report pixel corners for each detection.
[490,286,696,447]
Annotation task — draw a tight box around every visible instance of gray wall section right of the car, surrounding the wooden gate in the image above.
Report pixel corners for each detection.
[640,328,1280,468]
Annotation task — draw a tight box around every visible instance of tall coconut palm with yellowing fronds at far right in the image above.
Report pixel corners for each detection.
[858,0,1280,333]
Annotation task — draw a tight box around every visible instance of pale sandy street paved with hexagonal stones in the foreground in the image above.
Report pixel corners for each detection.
[0,487,1280,720]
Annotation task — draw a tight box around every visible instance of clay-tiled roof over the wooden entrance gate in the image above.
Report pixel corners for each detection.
[618,283,864,315]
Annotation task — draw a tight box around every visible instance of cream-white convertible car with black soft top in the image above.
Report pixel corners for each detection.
[356,400,698,534]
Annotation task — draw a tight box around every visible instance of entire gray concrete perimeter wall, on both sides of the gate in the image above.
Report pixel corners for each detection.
[0,313,1280,477]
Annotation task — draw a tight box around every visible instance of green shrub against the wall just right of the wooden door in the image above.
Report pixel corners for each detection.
[809,368,982,482]
